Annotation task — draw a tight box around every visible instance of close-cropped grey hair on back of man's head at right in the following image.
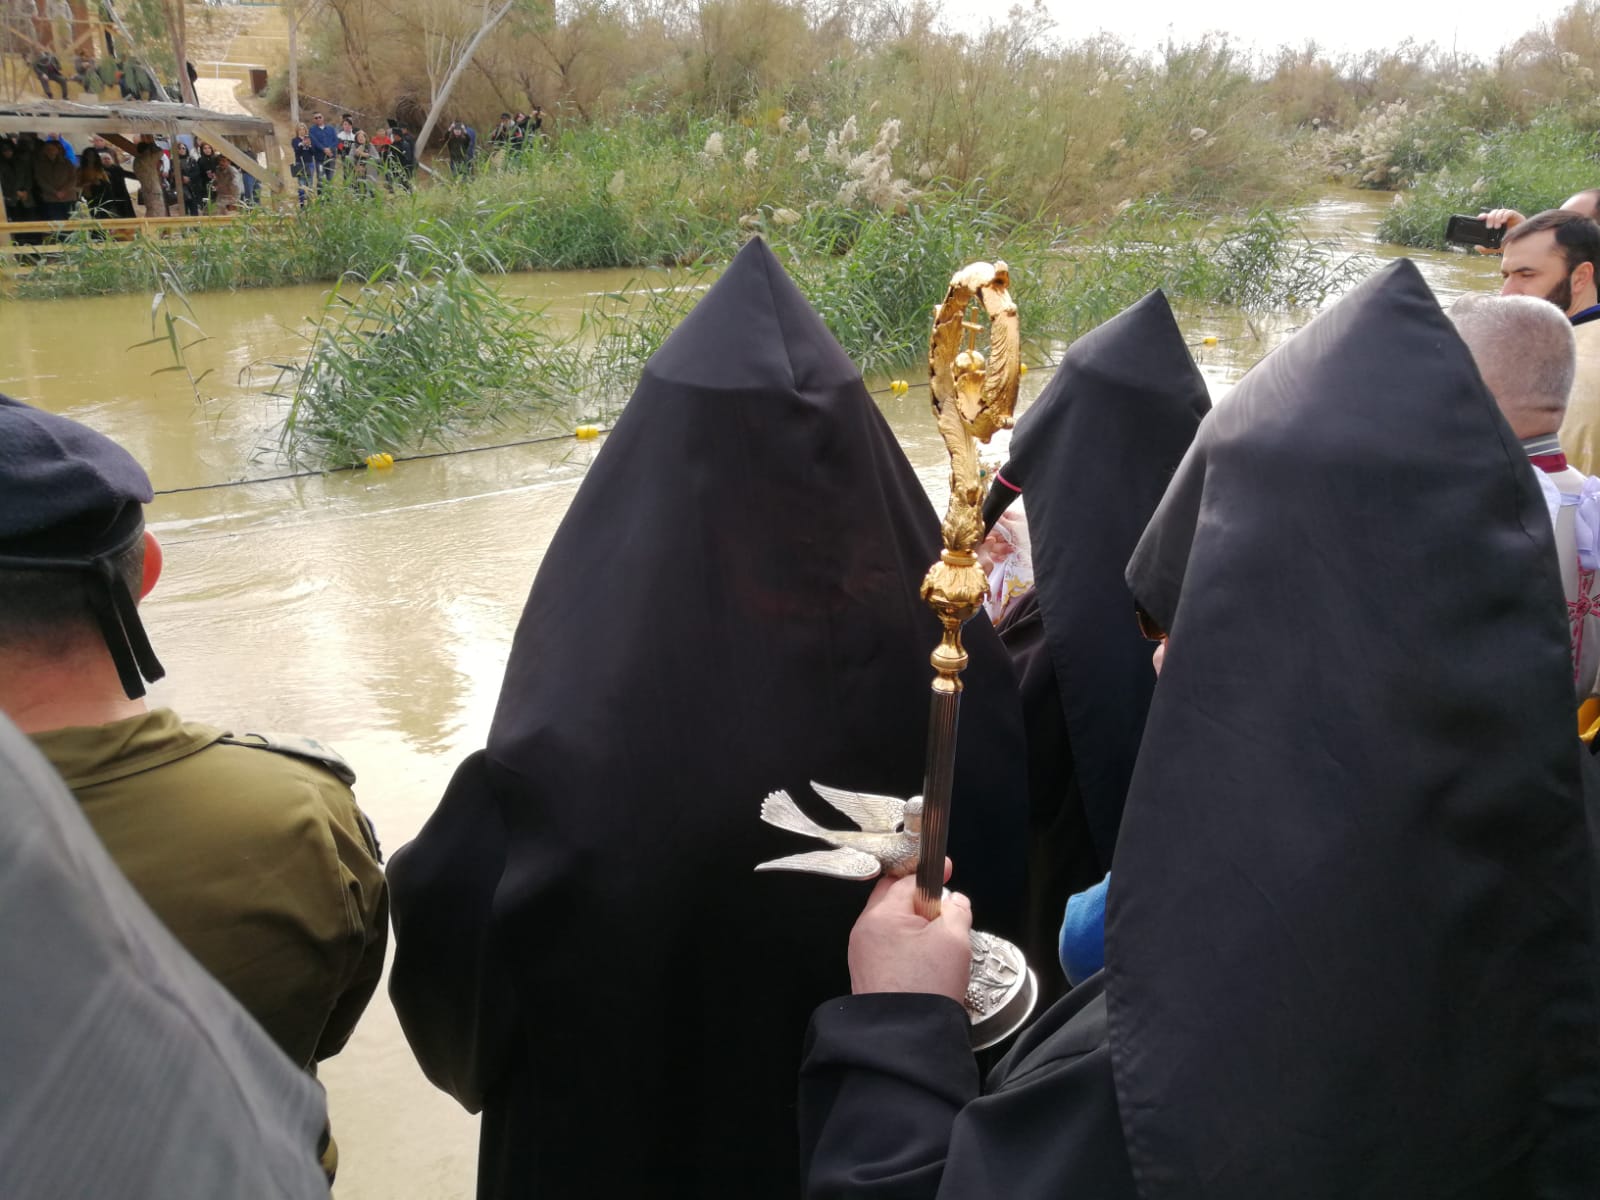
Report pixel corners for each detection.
[1450,296,1578,432]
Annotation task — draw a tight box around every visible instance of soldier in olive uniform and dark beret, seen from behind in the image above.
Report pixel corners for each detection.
[0,395,389,1170]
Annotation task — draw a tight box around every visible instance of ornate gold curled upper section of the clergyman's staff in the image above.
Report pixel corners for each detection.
[922,262,1021,693]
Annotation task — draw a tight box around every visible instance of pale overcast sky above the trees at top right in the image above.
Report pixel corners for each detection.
[942,0,1587,58]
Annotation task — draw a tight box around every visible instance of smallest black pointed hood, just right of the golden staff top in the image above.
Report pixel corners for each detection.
[989,291,1211,870]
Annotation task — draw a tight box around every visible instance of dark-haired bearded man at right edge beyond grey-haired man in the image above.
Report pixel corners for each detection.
[1501,208,1600,475]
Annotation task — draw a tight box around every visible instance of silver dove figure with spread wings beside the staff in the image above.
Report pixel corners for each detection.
[757,781,922,878]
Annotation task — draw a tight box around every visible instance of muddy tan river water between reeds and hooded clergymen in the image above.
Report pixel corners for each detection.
[0,192,1498,1200]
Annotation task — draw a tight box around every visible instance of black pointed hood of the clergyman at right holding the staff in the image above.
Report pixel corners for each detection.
[1106,261,1600,1200]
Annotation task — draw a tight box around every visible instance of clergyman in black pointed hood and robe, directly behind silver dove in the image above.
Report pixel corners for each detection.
[390,242,1026,1195]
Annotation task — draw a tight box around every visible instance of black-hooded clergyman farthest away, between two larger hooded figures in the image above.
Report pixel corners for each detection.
[984,291,1211,995]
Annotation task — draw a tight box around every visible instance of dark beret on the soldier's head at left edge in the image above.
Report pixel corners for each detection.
[0,395,155,555]
